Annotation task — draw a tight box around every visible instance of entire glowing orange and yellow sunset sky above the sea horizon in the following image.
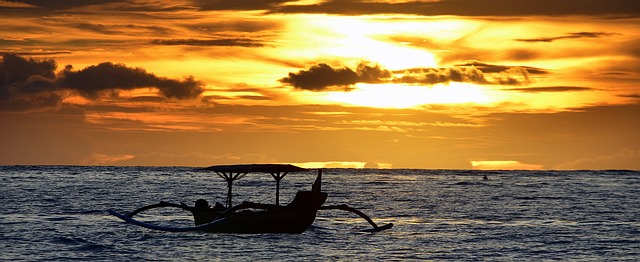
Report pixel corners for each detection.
[0,0,640,170]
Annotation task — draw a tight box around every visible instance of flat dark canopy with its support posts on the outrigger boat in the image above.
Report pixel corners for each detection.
[202,164,309,208]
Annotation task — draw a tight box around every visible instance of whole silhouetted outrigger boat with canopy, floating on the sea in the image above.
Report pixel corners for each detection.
[108,164,393,234]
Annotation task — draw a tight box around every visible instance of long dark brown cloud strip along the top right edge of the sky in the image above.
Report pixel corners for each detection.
[272,0,640,17]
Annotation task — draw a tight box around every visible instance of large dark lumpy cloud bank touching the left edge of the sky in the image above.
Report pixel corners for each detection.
[0,54,203,111]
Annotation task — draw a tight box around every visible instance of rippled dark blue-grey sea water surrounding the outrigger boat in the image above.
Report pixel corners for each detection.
[0,166,640,261]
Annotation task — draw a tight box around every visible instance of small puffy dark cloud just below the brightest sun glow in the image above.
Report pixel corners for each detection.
[280,62,392,91]
